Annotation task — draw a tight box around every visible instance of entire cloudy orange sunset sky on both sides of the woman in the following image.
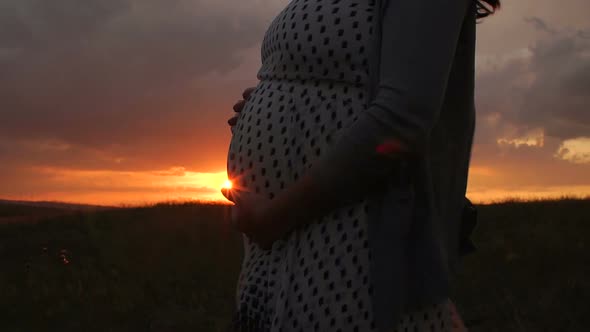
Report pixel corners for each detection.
[0,0,590,205]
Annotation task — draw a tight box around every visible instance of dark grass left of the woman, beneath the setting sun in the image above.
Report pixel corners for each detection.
[0,204,241,331]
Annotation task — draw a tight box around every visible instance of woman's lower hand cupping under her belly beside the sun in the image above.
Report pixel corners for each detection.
[221,188,288,250]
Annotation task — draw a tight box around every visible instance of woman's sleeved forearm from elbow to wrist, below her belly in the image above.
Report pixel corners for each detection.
[271,124,403,230]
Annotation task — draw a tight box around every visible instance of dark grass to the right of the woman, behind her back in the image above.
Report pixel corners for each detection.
[454,199,590,332]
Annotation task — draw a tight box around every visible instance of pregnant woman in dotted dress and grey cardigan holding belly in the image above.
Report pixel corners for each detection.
[223,0,499,332]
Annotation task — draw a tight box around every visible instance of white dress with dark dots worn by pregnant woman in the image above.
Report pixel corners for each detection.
[227,0,450,332]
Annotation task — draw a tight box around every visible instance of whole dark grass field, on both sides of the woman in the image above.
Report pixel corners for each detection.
[0,199,590,332]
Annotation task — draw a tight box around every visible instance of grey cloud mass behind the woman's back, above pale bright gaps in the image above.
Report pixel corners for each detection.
[477,25,590,143]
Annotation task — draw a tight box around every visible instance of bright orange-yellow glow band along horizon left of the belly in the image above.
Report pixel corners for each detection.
[0,167,236,206]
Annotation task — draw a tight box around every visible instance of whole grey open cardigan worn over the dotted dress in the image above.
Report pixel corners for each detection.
[309,0,476,332]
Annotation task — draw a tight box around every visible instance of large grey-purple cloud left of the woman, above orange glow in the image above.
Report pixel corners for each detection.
[0,0,280,168]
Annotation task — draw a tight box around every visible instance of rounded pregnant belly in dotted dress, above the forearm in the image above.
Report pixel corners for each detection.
[227,81,366,199]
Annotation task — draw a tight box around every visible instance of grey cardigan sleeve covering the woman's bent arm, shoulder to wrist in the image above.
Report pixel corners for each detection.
[306,0,475,208]
